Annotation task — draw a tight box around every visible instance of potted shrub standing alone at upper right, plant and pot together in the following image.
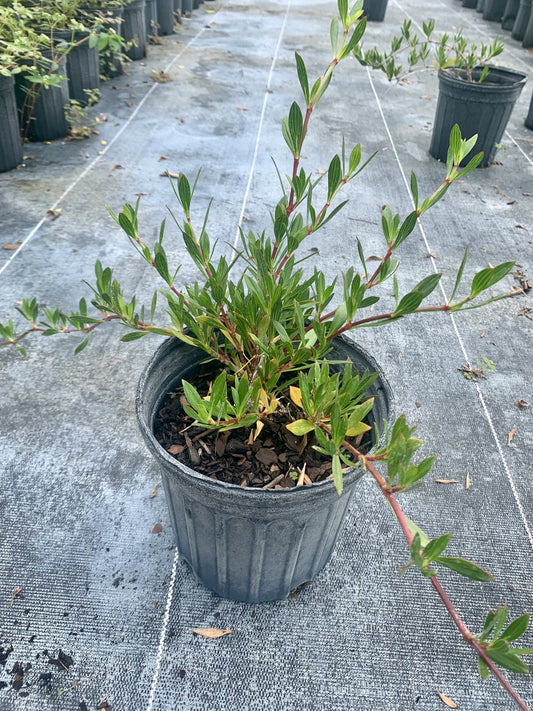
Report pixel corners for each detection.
[354,20,527,166]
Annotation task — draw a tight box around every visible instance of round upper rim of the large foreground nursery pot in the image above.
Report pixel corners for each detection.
[135,334,393,500]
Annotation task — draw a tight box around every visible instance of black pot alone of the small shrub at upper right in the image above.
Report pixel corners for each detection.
[429,66,527,166]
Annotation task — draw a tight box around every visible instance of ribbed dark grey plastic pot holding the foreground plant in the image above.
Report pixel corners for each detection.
[136,338,392,603]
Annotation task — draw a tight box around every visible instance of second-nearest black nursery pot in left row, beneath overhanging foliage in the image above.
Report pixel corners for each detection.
[15,52,70,141]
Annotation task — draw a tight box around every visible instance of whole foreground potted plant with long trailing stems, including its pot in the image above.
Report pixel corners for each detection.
[0,0,533,708]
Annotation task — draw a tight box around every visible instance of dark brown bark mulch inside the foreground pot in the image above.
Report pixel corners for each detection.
[154,372,371,489]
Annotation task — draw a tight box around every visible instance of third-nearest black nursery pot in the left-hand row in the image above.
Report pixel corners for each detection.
[54,30,100,105]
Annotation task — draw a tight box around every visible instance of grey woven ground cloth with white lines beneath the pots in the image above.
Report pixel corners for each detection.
[0,0,533,711]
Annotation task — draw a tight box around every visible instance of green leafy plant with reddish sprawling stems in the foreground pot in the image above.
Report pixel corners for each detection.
[0,0,533,709]
